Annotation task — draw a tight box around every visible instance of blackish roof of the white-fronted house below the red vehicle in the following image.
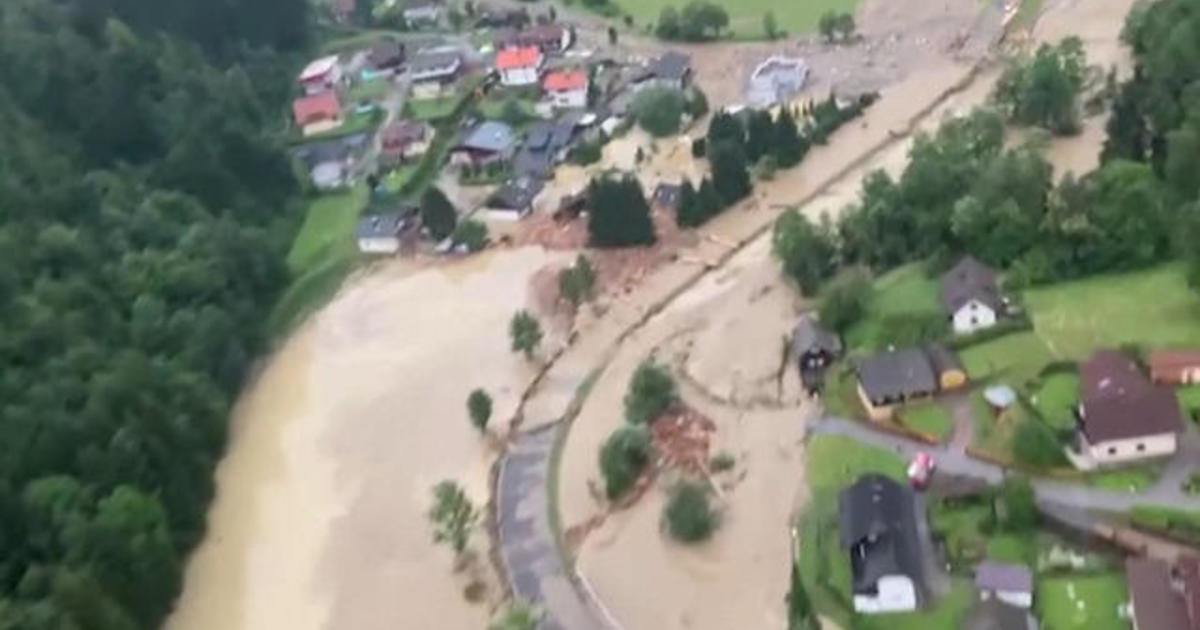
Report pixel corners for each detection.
[838,474,920,593]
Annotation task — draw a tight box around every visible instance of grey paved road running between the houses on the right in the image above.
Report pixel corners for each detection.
[810,416,1200,512]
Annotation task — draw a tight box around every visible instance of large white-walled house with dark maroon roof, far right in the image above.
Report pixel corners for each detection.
[1072,349,1183,468]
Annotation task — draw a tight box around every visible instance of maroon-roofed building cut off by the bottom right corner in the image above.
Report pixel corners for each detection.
[1126,557,1200,630]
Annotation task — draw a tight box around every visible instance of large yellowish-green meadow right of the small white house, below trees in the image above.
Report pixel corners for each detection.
[1025,264,1200,360]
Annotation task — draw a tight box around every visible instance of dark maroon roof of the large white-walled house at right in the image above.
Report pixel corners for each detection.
[1080,350,1182,444]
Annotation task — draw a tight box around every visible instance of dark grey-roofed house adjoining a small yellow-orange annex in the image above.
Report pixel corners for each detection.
[854,348,938,420]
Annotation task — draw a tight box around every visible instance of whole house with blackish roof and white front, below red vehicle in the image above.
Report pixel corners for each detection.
[838,474,920,614]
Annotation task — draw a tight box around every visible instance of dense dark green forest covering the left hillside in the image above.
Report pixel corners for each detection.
[0,0,308,630]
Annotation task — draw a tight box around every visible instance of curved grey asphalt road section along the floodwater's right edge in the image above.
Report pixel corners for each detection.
[496,424,608,630]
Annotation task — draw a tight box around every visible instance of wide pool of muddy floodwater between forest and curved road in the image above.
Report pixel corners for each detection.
[167,247,556,630]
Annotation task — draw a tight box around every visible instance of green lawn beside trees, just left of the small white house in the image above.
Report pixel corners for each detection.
[846,263,942,349]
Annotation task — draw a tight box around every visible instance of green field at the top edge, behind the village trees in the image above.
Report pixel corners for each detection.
[612,0,858,40]
